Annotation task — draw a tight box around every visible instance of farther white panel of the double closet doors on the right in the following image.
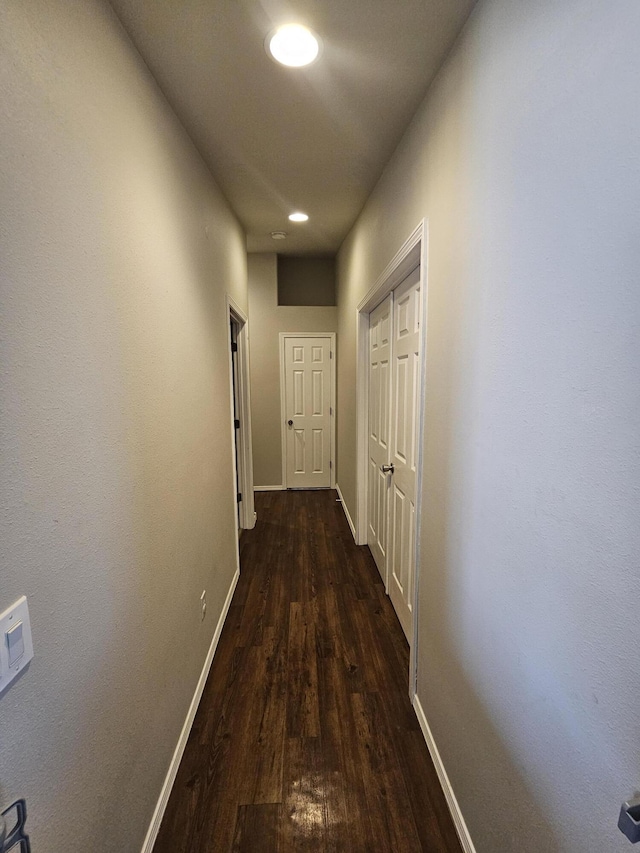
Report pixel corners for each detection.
[367,294,393,588]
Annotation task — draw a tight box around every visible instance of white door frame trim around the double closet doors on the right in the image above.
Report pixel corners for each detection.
[356,219,428,702]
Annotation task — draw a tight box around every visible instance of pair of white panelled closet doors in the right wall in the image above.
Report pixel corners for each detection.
[367,266,421,643]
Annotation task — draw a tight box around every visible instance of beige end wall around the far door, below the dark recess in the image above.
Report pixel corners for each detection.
[248,253,340,486]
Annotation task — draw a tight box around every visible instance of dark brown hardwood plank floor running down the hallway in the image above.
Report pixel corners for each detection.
[154,491,461,853]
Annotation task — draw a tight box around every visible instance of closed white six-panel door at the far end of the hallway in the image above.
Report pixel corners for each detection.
[284,336,332,489]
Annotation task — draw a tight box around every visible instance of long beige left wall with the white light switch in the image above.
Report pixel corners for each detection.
[0,0,247,853]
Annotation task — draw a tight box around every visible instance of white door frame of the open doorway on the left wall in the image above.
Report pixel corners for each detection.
[227,293,256,530]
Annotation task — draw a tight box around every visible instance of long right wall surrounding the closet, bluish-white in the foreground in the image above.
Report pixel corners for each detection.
[338,0,640,853]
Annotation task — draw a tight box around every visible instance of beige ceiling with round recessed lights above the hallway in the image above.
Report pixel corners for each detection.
[111,0,474,254]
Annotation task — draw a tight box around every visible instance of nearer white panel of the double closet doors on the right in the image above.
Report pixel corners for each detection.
[388,268,420,643]
